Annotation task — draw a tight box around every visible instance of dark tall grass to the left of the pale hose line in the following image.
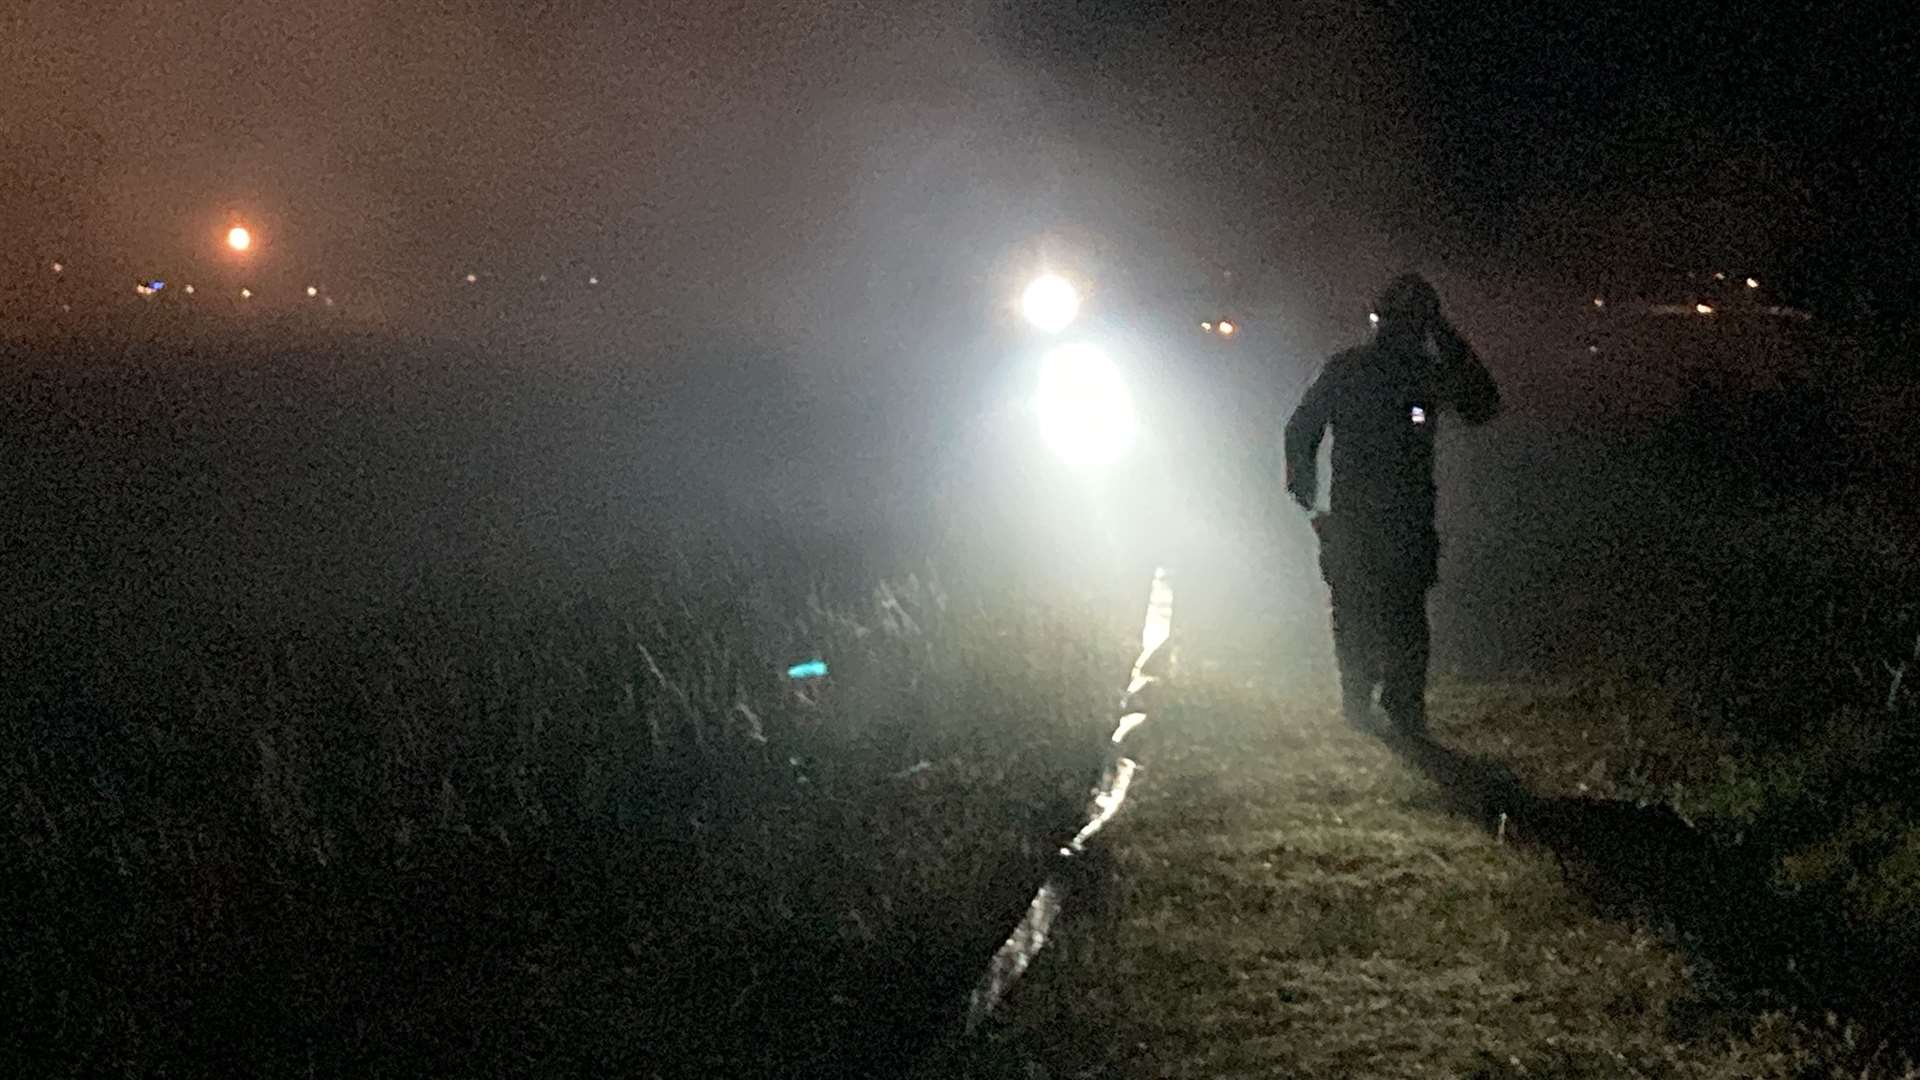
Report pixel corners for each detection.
[0,557,1125,1076]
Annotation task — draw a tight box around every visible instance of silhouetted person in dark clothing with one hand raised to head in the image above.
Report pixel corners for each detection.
[1286,273,1500,734]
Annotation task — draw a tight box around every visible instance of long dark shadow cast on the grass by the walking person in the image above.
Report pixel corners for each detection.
[1386,736,1920,1049]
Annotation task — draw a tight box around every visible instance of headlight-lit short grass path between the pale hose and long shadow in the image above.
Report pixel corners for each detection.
[970,680,1897,1078]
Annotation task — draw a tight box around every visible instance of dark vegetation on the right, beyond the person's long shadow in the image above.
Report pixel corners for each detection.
[1407,474,1920,1053]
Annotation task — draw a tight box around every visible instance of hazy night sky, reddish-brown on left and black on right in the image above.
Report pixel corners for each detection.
[0,0,1920,328]
